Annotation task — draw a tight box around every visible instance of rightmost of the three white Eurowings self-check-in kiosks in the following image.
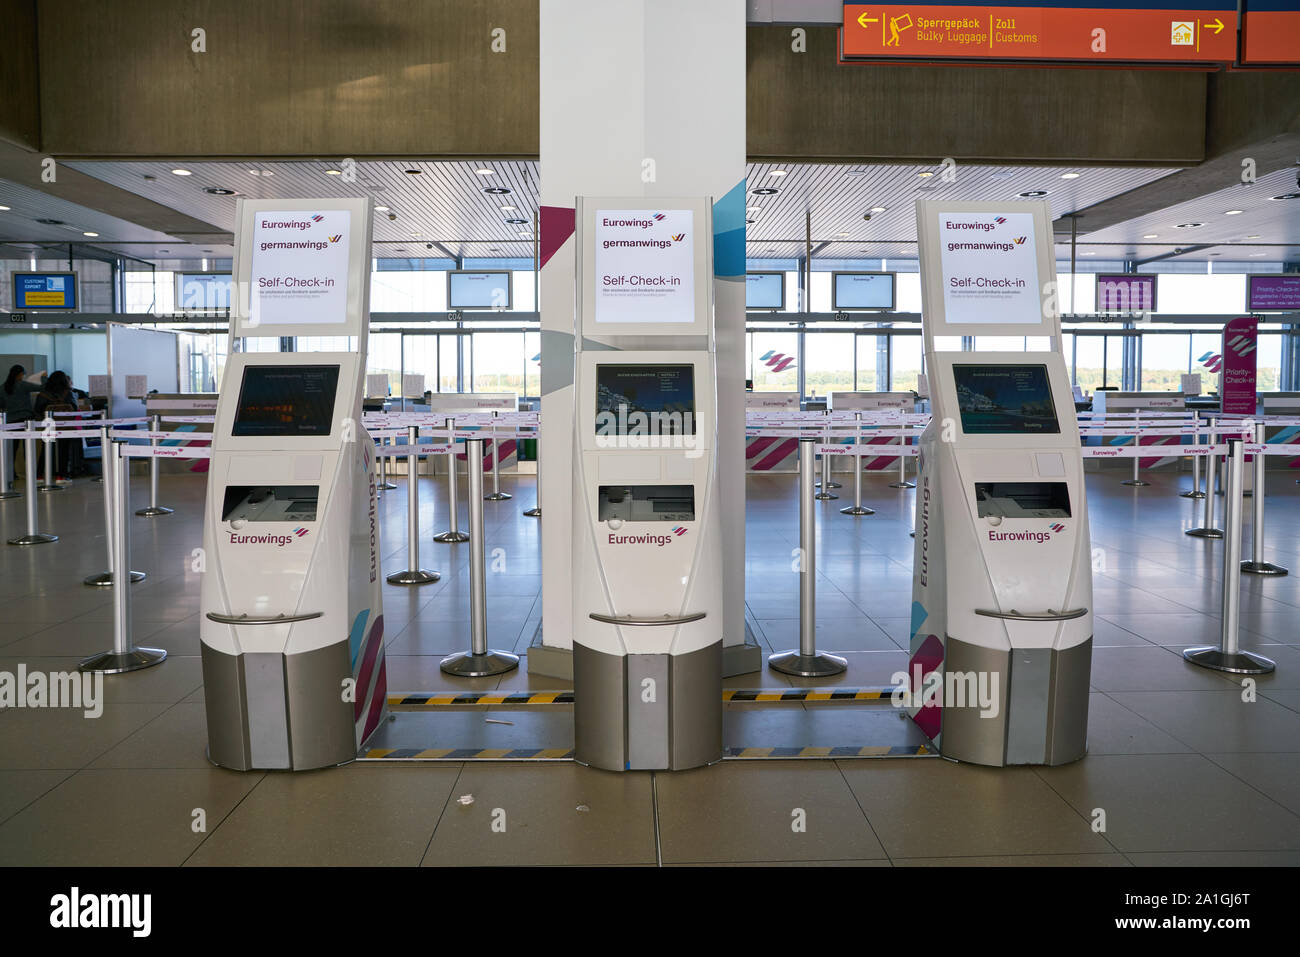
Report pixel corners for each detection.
[909,202,1092,766]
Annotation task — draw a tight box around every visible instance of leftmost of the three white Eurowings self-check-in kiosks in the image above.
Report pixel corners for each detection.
[200,199,386,770]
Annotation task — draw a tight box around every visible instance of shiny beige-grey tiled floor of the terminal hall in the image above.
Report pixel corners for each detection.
[0,462,1300,866]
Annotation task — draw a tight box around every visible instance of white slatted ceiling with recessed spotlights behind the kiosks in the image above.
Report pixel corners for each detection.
[0,160,1300,261]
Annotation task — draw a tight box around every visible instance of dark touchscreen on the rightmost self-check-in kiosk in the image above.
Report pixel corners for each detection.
[953,365,1061,436]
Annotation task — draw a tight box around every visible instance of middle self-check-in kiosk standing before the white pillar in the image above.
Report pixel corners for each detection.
[573,198,723,771]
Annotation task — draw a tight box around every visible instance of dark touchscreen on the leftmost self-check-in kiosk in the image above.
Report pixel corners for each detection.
[231,365,338,437]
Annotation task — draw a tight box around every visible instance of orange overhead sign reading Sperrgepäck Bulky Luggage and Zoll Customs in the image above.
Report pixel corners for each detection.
[844,4,1236,64]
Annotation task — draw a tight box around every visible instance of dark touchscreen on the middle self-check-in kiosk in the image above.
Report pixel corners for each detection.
[595,363,696,436]
